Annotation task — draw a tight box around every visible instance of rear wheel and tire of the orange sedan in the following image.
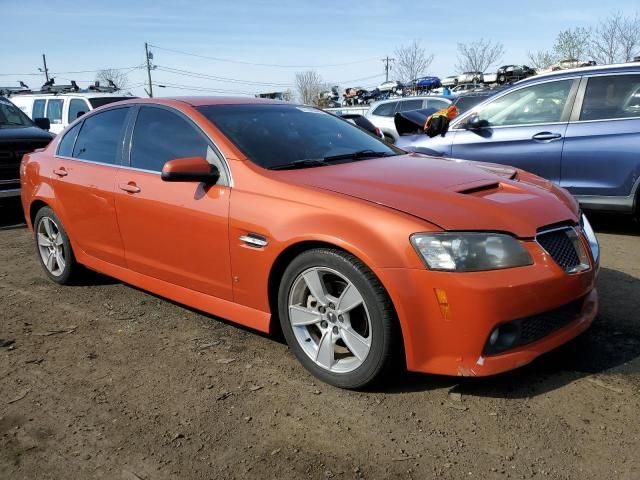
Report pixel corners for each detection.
[33,207,81,285]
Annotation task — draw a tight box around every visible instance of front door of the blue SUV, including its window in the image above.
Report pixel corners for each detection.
[448,78,579,182]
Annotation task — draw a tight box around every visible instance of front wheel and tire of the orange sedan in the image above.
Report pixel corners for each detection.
[278,248,401,389]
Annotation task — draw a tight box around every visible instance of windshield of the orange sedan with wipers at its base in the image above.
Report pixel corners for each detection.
[198,104,404,168]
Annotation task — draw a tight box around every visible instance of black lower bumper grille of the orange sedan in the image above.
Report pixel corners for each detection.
[483,297,584,355]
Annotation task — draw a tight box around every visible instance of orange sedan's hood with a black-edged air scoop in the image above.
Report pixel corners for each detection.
[278,154,578,238]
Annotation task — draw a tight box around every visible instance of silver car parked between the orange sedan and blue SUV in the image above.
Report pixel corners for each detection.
[366,95,453,143]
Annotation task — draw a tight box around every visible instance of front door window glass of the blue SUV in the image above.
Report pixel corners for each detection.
[478,79,574,127]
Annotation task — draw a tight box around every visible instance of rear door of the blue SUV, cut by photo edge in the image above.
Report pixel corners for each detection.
[560,72,640,203]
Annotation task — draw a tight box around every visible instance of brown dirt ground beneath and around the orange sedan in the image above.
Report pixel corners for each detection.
[0,197,640,480]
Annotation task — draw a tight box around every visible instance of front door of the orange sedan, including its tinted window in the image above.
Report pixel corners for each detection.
[116,106,232,300]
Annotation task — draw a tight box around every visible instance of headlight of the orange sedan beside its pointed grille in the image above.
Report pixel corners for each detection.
[411,232,533,272]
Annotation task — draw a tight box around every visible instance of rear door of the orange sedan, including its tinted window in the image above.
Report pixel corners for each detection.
[52,107,131,266]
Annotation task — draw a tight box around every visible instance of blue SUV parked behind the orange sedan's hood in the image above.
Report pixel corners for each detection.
[397,63,640,216]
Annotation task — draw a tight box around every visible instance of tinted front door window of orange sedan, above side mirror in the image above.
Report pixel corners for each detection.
[131,107,208,172]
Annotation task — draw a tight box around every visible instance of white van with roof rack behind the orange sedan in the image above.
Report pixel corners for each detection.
[11,91,134,135]
